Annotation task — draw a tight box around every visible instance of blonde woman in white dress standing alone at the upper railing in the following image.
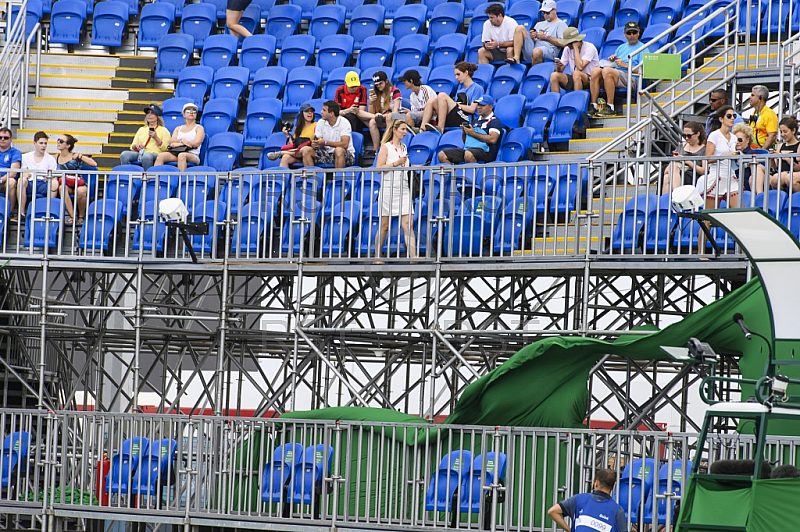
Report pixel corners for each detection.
[375,120,417,263]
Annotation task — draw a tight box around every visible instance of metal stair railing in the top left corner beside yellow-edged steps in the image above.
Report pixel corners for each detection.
[0,0,42,128]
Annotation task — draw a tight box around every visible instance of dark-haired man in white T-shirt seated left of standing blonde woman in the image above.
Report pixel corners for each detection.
[299,100,356,168]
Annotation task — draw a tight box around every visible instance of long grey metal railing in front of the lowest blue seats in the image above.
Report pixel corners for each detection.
[0,410,800,531]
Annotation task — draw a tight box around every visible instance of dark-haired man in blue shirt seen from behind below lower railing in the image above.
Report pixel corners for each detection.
[547,469,627,532]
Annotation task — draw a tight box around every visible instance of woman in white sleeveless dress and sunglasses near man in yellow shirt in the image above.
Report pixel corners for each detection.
[696,105,739,209]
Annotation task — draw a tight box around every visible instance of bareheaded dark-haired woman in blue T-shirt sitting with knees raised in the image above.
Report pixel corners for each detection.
[420,61,483,133]
